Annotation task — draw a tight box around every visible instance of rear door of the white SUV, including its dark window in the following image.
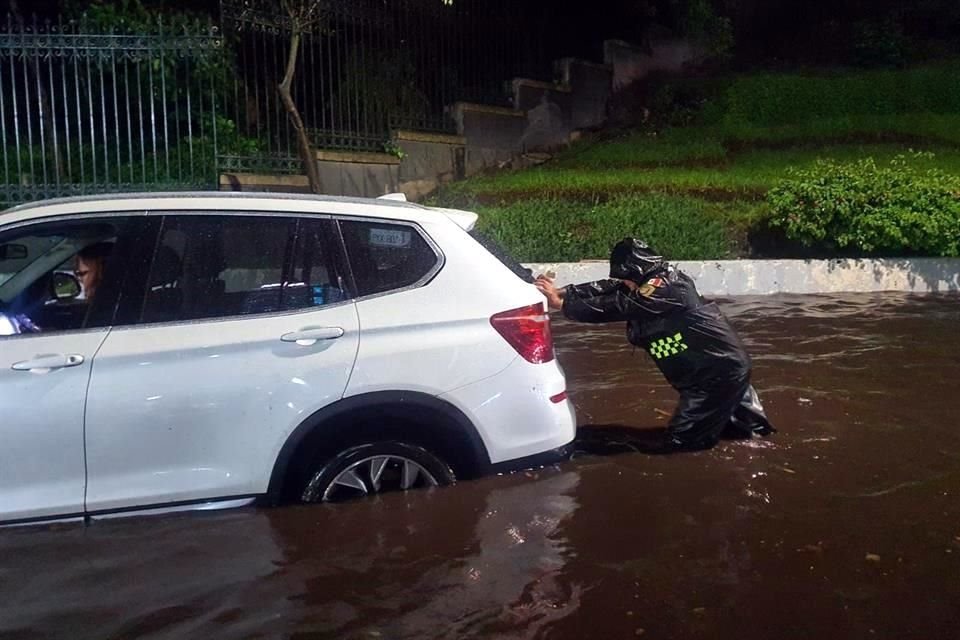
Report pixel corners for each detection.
[86,213,359,512]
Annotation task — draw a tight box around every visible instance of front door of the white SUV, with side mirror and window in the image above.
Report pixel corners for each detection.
[0,216,142,522]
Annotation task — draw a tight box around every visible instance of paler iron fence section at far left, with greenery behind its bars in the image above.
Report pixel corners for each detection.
[0,17,222,204]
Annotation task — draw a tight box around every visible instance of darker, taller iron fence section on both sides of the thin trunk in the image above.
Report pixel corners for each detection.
[221,0,550,162]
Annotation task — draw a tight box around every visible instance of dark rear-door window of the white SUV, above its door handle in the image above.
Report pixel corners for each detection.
[141,214,349,323]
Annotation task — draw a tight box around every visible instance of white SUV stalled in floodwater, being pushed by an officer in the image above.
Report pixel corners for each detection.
[0,193,575,523]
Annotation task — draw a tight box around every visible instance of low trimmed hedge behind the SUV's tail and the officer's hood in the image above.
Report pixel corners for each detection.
[468,195,732,262]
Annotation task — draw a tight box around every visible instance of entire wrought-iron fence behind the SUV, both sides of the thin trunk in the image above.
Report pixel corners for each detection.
[0,0,550,205]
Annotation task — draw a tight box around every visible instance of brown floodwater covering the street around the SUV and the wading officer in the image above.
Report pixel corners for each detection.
[0,295,960,640]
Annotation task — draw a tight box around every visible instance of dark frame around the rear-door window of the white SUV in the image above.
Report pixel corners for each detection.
[115,208,356,331]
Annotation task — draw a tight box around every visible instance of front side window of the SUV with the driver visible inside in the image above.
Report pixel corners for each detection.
[0,217,136,336]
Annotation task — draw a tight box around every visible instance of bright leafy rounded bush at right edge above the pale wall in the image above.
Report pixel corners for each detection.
[767,154,960,256]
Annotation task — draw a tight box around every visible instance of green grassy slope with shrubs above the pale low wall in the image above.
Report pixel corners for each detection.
[439,62,960,261]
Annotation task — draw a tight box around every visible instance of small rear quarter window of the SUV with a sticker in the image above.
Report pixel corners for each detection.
[340,220,440,296]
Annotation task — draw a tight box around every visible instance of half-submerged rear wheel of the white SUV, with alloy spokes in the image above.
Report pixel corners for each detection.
[300,441,455,502]
